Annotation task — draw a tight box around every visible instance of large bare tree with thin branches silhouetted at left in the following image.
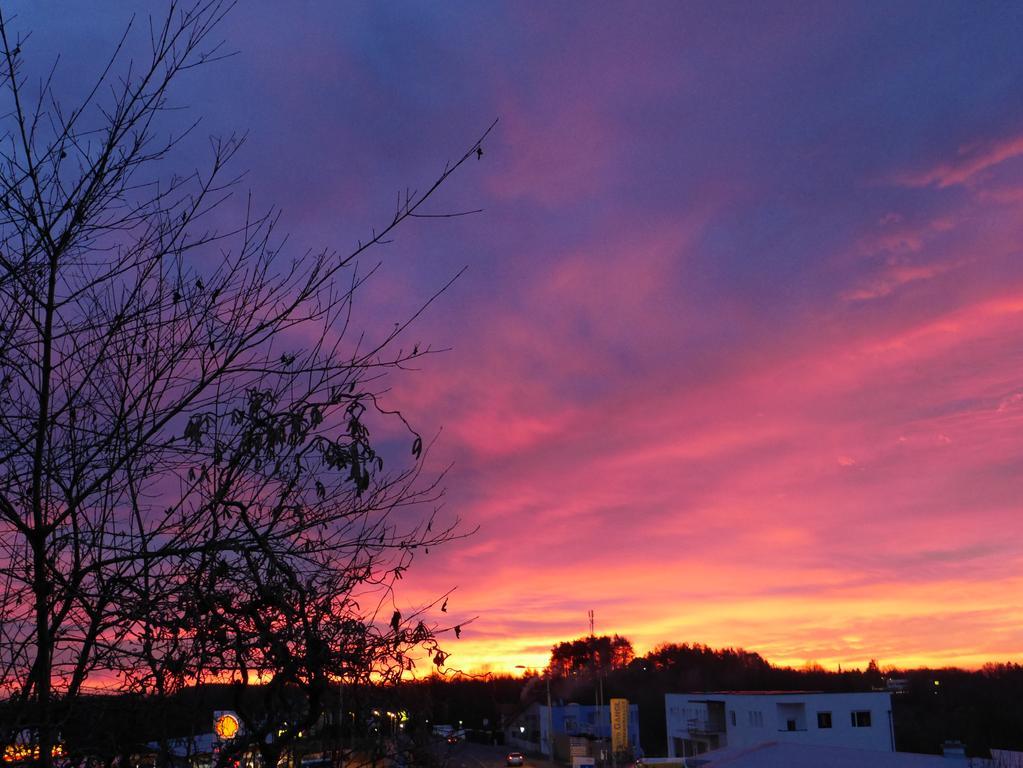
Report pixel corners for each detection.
[0,0,493,766]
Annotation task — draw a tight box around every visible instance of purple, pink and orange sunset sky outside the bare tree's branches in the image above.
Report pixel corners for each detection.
[21,0,1023,671]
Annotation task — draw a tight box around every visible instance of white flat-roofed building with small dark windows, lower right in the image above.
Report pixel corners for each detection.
[664,691,895,758]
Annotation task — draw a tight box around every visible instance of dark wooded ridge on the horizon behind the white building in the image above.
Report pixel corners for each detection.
[416,635,1023,756]
